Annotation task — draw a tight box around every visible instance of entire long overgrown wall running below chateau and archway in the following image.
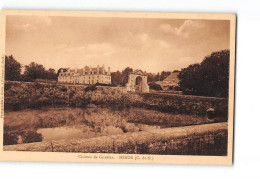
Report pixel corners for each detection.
[4,82,228,117]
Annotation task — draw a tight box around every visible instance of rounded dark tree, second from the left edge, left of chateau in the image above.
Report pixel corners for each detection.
[24,62,46,81]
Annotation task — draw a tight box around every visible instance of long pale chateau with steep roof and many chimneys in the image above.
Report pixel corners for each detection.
[58,65,111,84]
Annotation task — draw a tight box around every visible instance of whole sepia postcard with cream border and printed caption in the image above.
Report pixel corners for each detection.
[0,10,236,165]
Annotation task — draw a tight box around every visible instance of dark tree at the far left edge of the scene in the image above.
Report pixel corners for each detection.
[5,55,22,81]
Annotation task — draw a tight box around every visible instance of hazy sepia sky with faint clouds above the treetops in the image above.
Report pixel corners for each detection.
[6,16,230,73]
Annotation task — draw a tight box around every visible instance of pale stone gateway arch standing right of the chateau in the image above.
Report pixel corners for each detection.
[126,70,149,93]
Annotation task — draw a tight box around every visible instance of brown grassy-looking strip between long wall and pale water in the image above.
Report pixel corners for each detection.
[4,107,215,131]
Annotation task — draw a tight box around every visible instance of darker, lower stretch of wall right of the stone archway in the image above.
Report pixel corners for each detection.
[142,93,228,117]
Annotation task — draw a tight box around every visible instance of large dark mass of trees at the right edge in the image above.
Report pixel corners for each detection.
[178,50,230,97]
